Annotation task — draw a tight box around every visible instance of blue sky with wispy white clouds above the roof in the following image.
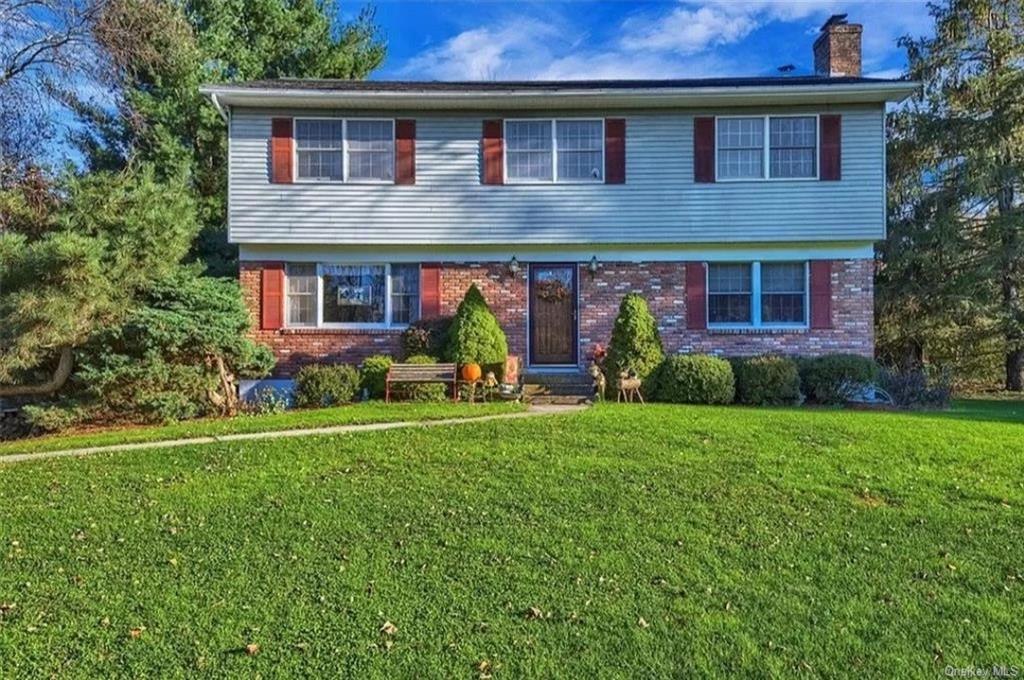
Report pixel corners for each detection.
[368,0,932,80]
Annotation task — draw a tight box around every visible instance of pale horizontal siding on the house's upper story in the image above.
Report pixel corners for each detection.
[228,105,885,244]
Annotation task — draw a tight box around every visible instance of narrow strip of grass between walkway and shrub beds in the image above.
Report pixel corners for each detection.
[0,401,525,456]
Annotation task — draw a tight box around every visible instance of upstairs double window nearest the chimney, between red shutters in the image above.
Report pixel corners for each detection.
[715,116,818,181]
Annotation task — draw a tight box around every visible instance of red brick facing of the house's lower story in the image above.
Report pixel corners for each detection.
[240,259,874,377]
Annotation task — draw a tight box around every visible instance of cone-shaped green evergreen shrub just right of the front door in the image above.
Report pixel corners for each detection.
[604,293,665,394]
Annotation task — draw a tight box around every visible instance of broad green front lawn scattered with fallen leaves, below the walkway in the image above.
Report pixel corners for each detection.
[0,402,1024,678]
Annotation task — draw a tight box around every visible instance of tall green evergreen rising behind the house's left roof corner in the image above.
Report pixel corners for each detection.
[68,0,385,275]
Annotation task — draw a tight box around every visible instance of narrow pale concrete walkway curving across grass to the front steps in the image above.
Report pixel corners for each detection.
[0,405,587,465]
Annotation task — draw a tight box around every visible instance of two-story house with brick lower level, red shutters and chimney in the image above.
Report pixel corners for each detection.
[203,17,914,393]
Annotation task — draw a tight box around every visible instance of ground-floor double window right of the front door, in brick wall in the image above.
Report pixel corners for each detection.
[708,262,807,328]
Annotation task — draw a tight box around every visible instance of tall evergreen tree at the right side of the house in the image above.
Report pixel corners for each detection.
[879,0,1024,391]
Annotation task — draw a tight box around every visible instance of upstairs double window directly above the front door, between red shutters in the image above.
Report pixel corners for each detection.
[505,120,604,182]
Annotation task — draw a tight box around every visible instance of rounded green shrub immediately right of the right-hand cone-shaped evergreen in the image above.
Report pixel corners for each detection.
[654,354,735,403]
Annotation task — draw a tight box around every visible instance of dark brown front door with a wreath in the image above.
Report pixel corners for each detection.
[529,264,577,366]
